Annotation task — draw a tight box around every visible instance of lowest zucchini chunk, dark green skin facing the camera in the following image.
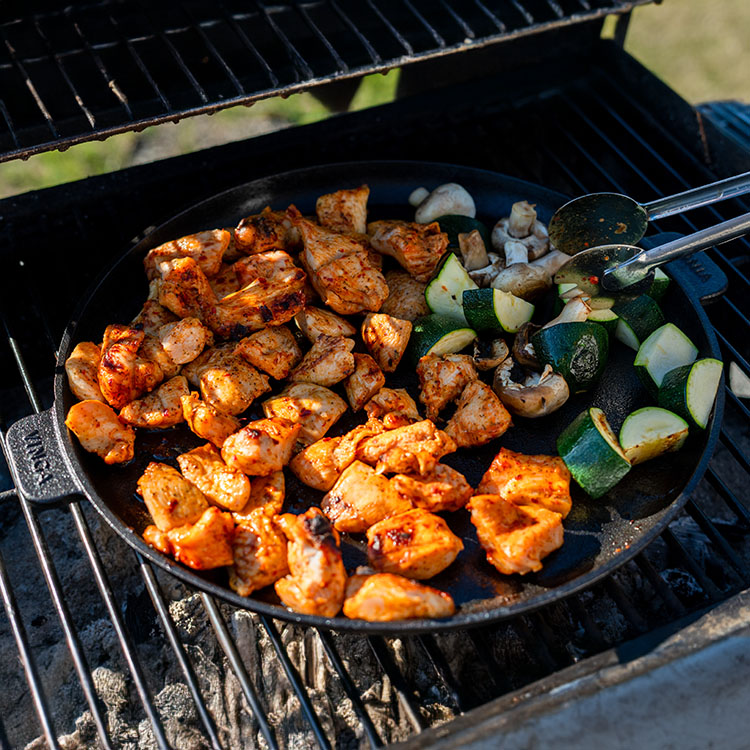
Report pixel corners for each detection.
[557,406,630,499]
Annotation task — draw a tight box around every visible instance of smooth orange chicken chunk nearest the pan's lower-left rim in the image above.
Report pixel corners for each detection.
[167,506,234,570]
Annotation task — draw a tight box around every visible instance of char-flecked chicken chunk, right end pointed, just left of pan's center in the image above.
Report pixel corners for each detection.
[221,418,302,477]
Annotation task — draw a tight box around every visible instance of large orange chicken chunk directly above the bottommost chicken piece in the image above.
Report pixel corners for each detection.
[367,508,464,580]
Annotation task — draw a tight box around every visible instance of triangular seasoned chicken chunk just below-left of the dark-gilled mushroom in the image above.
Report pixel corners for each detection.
[445,380,511,448]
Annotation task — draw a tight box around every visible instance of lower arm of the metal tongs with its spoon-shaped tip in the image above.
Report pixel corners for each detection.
[555,213,750,296]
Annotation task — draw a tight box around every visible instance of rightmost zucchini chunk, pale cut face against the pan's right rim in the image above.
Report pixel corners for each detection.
[657,357,724,430]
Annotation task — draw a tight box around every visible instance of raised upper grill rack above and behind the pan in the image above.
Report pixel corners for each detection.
[0,0,649,160]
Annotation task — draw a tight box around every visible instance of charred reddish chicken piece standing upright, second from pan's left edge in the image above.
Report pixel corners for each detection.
[97,325,145,409]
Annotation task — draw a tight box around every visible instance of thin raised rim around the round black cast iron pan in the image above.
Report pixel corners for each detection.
[53,160,724,635]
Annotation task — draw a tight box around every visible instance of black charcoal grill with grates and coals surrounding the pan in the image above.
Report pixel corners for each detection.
[0,0,750,748]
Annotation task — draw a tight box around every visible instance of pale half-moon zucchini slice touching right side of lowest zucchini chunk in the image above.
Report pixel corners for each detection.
[620,406,689,466]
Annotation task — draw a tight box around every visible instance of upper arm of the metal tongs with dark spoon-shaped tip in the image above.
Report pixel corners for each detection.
[549,172,750,255]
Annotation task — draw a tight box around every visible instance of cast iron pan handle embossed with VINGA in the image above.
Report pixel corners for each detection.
[6,409,81,503]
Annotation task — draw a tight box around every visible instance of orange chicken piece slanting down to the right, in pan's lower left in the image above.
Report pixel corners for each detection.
[177,443,250,510]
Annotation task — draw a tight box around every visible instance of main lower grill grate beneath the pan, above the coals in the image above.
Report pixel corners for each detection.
[0,42,750,748]
